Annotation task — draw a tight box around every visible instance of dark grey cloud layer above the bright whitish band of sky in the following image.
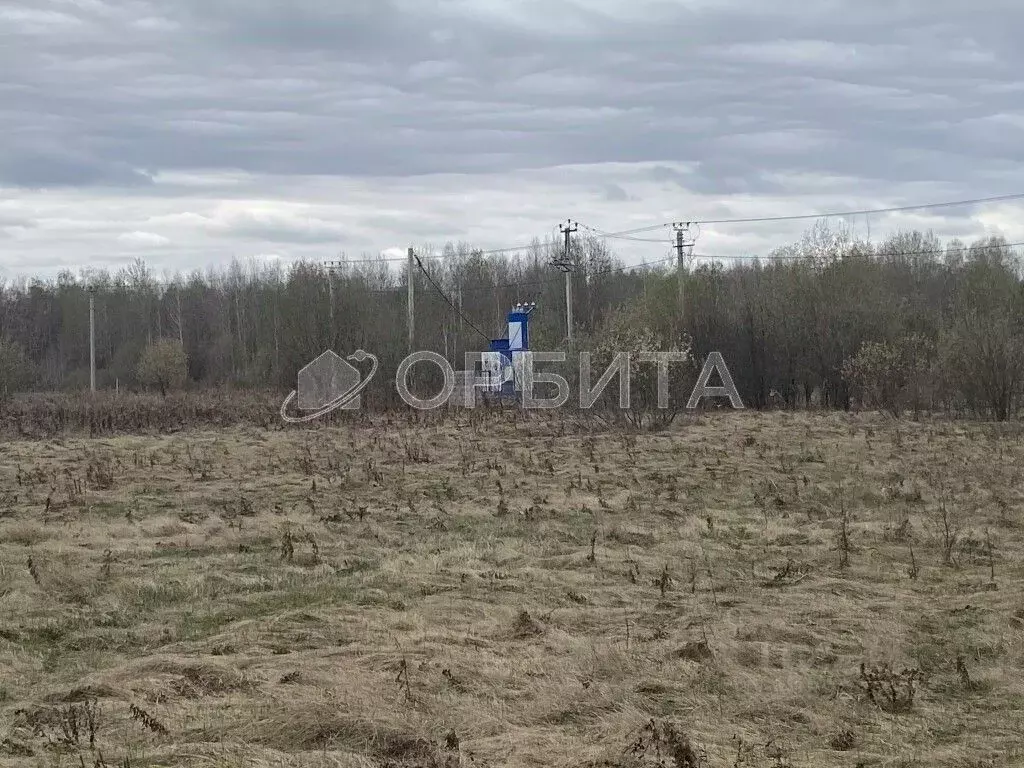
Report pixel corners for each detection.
[0,0,1024,274]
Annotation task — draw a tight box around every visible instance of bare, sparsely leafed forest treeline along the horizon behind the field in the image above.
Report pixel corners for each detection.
[0,223,1024,419]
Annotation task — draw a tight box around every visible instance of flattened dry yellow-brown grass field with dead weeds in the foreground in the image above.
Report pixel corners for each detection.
[0,413,1024,768]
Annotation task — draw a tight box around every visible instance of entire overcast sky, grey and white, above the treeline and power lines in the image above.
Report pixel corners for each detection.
[0,0,1024,279]
